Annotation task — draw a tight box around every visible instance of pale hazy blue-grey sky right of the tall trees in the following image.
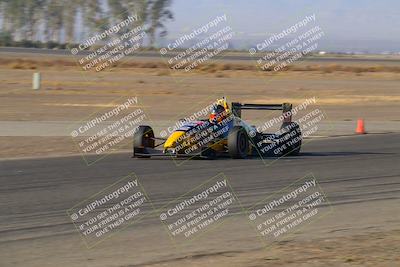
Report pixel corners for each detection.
[162,0,400,52]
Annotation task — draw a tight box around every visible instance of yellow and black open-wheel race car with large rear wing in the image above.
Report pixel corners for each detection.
[133,97,302,159]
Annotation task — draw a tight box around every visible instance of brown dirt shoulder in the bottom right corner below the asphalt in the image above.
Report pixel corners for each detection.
[146,230,400,267]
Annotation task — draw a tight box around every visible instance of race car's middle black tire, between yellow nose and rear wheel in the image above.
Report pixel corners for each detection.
[228,126,249,159]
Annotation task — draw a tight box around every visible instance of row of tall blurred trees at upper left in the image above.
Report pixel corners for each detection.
[0,0,173,48]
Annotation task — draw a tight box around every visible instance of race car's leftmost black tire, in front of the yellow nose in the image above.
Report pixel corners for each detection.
[133,125,155,158]
